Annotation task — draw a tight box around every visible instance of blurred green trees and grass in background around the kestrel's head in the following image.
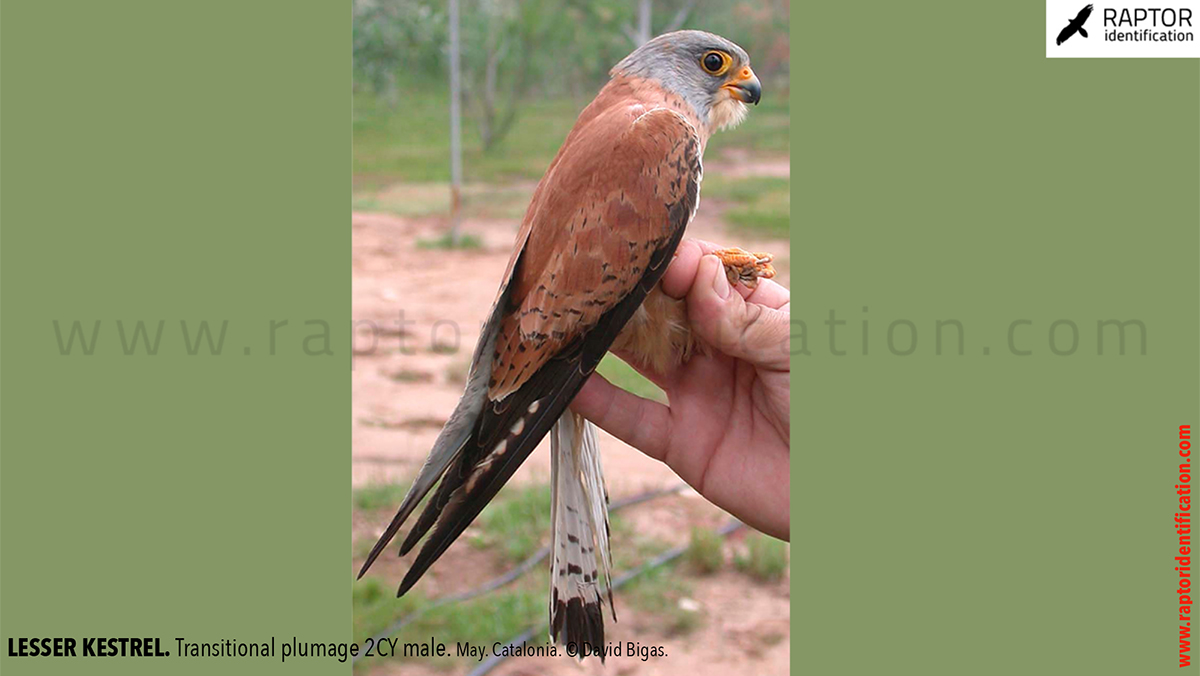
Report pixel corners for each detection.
[352,0,788,176]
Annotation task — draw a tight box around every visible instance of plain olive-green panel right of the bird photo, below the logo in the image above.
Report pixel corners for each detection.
[792,2,1200,675]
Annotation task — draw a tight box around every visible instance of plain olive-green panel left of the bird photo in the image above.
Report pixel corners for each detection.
[0,0,350,674]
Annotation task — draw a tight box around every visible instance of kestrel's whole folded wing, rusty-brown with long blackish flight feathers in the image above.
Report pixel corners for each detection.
[384,106,701,594]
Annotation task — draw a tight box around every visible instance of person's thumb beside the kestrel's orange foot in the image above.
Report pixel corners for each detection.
[688,256,791,371]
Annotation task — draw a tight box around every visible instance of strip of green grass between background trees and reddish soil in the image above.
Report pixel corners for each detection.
[353,88,790,225]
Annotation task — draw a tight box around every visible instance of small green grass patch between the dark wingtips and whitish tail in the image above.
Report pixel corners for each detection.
[470,484,550,563]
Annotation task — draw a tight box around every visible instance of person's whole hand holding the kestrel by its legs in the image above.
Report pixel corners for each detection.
[571,240,791,540]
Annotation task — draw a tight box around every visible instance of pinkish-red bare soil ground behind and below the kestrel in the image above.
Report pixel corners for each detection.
[352,160,790,676]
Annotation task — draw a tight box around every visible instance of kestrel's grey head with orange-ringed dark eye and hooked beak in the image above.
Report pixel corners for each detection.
[611,30,762,130]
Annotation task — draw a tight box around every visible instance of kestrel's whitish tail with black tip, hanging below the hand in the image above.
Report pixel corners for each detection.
[550,411,617,662]
